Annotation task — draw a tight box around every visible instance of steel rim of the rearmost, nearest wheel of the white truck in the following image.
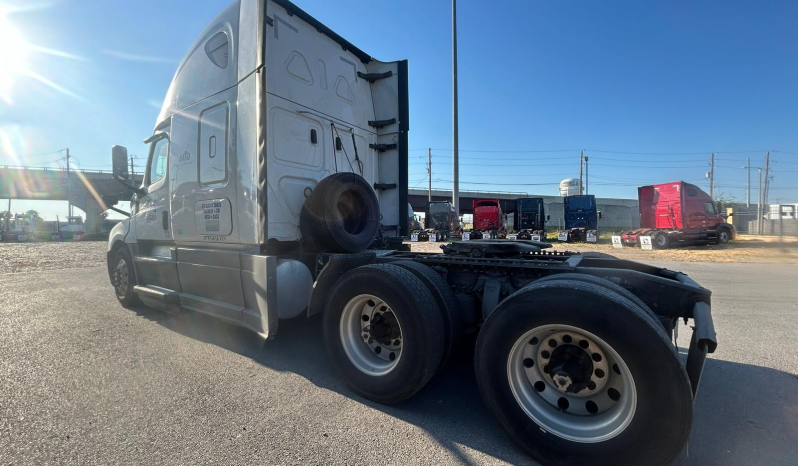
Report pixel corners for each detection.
[507,324,637,443]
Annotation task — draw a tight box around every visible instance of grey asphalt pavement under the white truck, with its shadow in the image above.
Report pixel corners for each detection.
[0,262,798,465]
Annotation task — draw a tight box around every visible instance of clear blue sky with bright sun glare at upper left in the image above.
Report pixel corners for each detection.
[0,0,798,219]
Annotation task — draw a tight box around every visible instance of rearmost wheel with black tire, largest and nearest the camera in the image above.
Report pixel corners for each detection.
[475,280,693,465]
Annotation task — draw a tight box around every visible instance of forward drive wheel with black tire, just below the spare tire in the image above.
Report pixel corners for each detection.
[323,264,445,404]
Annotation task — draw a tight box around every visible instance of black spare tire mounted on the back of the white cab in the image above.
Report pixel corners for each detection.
[299,173,380,252]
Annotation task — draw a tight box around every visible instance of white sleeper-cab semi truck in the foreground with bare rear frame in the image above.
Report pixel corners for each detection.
[108,0,717,465]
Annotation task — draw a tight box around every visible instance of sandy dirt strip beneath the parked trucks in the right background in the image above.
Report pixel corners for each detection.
[410,235,798,264]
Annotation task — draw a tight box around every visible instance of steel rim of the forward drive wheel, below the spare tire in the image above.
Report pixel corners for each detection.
[340,294,403,376]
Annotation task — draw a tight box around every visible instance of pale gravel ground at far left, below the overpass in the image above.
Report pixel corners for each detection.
[0,241,108,275]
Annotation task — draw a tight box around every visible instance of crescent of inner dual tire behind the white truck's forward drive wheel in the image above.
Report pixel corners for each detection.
[393,261,464,366]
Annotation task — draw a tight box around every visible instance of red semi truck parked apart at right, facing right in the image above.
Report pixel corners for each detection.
[621,181,736,249]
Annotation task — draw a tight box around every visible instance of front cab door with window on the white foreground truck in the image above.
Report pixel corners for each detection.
[133,128,172,242]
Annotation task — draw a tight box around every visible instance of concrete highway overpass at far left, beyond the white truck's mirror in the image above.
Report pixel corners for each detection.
[0,166,142,233]
